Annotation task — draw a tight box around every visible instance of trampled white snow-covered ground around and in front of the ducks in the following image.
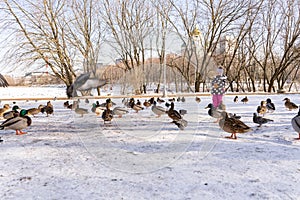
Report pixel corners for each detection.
[0,85,300,200]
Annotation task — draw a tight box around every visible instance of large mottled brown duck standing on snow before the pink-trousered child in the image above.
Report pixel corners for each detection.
[219,111,252,139]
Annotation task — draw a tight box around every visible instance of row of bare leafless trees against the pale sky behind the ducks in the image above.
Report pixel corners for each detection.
[0,0,300,92]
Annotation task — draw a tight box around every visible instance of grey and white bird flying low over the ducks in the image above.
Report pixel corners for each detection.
[66,72,107,98]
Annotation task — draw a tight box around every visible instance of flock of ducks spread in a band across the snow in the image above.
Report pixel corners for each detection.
[0,96,300,141]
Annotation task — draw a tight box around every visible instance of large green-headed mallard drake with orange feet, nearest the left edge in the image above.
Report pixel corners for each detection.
[0,109,32,135]
